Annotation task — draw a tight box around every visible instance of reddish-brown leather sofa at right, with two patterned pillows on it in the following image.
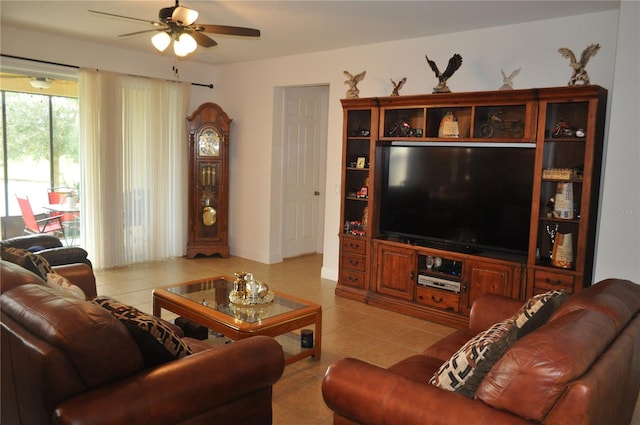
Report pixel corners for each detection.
[322,279,640,425]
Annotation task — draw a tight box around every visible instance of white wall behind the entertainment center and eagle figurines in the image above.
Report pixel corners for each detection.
[212,11,640,281]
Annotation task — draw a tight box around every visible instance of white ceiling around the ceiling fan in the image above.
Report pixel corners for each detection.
[0,0,619,64]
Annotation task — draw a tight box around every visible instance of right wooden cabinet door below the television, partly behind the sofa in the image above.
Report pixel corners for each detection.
[462,260,520,315]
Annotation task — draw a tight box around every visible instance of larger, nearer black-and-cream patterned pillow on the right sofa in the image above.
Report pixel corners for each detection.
[429,320,517,397]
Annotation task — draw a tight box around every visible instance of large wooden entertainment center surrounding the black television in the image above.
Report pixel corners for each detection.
[335,85,607,327]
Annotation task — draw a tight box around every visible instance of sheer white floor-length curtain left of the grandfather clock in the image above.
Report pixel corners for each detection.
[79,69,190,269]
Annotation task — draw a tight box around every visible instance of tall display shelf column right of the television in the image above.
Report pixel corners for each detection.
[528,86,606,294]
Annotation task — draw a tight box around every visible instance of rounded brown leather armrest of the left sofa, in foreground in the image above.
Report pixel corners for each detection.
[54,336,284,425]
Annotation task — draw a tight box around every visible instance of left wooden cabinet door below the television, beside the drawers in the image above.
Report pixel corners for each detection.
[375,244,417,301]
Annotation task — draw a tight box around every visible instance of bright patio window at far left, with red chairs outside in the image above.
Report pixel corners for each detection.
[0,72,80,238]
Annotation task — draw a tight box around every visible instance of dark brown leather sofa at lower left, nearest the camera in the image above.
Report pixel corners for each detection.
[0,253,284,425]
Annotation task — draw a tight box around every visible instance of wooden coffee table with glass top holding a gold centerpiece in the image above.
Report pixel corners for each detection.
[153,276,322,364]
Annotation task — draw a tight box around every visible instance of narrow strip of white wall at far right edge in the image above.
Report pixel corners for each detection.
[595,1,640,283]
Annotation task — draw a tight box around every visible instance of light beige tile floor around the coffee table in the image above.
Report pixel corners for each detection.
[96,255,640,425]
